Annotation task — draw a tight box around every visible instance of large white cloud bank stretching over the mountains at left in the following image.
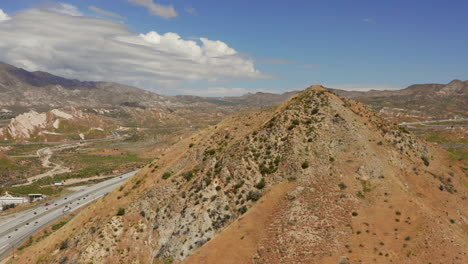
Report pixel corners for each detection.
[0,6,268,91]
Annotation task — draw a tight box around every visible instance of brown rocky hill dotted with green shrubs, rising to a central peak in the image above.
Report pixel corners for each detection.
[15,86,468,264]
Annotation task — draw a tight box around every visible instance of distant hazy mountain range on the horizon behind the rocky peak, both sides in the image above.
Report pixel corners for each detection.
[0,63,468,124]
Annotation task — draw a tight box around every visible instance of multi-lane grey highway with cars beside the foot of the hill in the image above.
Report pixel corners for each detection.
[0,170,138,260]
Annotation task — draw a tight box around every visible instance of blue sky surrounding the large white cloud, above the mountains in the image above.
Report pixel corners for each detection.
[0,0,468,95]
